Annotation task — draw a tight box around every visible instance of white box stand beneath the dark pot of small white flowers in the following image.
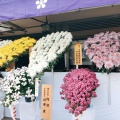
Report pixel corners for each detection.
[19,97,41,120]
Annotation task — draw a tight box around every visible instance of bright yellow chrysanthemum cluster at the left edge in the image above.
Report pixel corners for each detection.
[0,37,36,67]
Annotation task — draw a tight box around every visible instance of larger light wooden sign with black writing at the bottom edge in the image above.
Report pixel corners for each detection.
[41,84,52,120]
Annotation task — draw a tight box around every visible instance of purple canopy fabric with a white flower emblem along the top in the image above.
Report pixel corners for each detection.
[0,0,120,22]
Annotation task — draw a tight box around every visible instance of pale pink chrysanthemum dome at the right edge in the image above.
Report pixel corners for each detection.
[84,32,120,70]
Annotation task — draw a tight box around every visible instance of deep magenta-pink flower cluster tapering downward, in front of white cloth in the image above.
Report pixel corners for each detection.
[60,68,99,116]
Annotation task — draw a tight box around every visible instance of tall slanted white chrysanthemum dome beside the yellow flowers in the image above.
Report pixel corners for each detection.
[28,31,72,77]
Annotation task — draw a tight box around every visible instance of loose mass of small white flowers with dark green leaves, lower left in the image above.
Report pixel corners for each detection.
[0,67,37,107]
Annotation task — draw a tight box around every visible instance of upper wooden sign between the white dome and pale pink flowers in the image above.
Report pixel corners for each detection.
[74,43,82,65]
